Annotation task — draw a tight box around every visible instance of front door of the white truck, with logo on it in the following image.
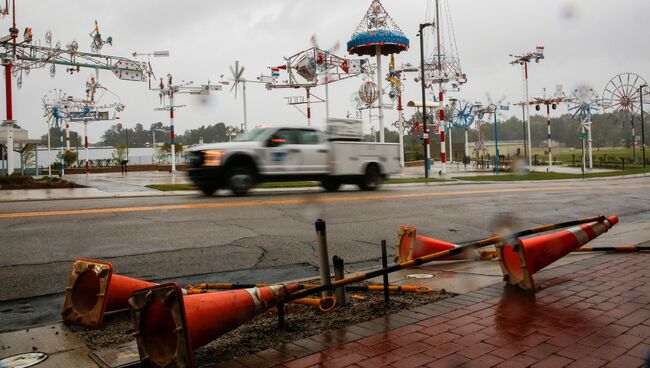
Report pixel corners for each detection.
[264,129,302,175]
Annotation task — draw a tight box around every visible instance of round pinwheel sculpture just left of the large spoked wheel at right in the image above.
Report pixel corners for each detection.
[569,86,602,171]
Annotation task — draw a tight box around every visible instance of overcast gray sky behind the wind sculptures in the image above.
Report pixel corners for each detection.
[0,0,650,142]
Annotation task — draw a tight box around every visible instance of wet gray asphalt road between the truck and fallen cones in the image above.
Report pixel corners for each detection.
[0,177,650,302]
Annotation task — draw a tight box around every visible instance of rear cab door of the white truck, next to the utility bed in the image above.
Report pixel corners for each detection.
[296,129,330,174]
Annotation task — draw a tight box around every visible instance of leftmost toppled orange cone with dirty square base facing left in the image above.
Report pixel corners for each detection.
[61,258,156,327]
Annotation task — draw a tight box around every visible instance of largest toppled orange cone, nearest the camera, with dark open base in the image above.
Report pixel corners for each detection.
[129,283,301,367]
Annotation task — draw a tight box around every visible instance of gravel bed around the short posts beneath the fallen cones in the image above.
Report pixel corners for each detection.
[70,290,454,366]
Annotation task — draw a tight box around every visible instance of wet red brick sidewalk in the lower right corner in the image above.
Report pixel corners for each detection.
[218,253,650,368]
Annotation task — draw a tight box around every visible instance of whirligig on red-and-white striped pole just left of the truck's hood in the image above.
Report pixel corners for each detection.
[152,74,225,173]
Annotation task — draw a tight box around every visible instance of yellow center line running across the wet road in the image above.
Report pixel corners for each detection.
[0,184,650,218]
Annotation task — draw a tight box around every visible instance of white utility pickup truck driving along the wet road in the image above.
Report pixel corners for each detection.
[188,127,400,196]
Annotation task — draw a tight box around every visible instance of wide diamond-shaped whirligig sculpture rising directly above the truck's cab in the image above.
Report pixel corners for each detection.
[257,45,368,126]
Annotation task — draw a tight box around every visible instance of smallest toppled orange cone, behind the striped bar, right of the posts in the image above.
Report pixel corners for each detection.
[395,226,459,263]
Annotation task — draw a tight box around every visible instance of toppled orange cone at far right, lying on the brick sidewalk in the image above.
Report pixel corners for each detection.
[497,216,618,291]
